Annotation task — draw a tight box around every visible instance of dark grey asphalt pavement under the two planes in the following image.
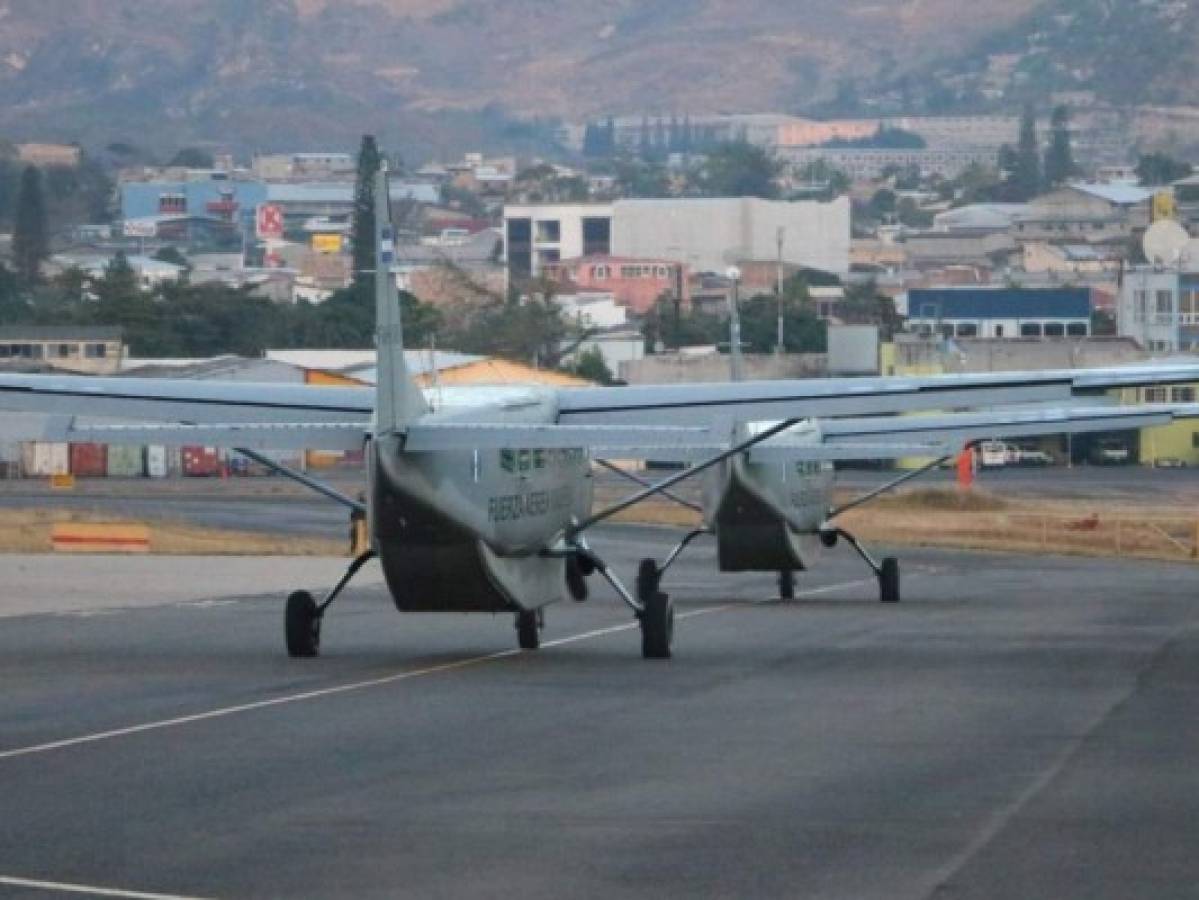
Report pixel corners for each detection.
[0,526,1199,900]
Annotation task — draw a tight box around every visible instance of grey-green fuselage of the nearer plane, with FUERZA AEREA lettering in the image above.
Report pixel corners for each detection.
[368,392,592,612]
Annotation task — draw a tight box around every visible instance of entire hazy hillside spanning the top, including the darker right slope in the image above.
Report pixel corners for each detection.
[0,0,1199,156]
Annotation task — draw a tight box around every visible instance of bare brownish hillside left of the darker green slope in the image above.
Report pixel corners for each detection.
[0,0,1035,152]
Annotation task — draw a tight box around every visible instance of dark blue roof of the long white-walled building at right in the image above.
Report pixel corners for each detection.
[908,288,1091,319]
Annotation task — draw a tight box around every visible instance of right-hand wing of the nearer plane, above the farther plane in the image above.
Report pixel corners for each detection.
[558,363,1199,425]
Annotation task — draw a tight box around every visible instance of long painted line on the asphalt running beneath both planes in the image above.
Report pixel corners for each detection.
[0,579,873,761]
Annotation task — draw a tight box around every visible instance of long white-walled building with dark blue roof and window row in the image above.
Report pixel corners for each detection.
[906,288,1091,339]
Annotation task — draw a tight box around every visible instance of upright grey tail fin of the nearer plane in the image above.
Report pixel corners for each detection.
[374,167,429,435]
